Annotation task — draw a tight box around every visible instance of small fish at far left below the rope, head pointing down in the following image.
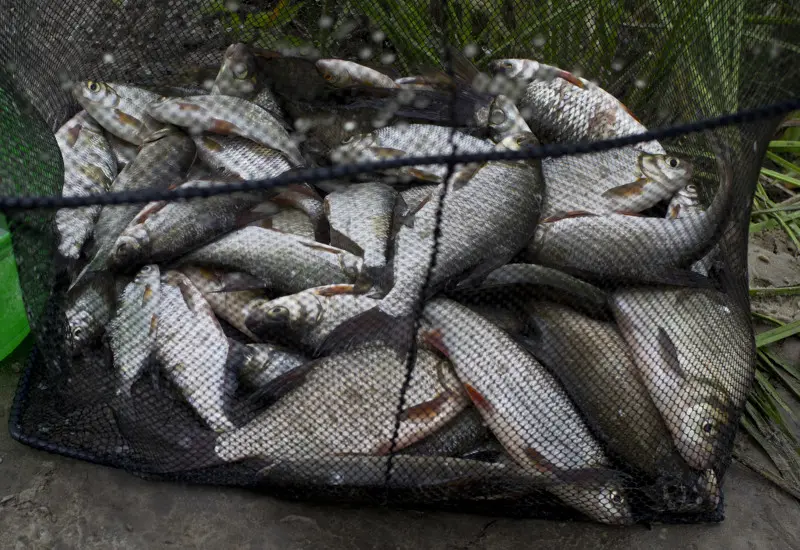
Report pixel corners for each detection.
[64,272,116,355]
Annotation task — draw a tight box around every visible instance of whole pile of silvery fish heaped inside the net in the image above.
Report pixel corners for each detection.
[56,44,753,524]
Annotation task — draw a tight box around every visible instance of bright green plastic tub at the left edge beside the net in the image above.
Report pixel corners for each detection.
[0,214,30,361]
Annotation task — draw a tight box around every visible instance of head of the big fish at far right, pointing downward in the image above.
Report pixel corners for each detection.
[676,402,730,470]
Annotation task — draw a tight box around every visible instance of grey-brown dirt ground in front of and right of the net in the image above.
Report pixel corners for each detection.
[0,233,800,550]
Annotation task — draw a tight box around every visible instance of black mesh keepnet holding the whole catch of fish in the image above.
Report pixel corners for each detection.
[0,0,800,524]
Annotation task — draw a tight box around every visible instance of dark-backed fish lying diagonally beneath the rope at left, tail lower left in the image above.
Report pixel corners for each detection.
[73,128,195,285]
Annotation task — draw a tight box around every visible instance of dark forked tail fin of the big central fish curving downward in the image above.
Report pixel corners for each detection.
[316,306,415,357]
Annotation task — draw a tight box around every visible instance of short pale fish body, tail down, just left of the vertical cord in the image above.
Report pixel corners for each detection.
[325,182,402,280]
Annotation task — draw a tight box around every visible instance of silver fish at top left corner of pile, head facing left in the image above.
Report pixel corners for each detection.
[72,80,162,145]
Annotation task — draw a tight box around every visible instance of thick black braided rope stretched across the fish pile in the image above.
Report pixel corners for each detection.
[0,99,800,210]
